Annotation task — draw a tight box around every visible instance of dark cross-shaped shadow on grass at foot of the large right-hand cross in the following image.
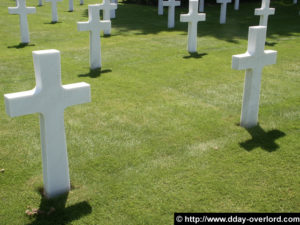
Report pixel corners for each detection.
[240,124,285,152]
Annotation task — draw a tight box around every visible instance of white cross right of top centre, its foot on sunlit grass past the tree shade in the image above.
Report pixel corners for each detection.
[180,0,206,53]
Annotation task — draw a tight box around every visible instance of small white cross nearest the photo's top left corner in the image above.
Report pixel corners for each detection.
[8,0,36,43]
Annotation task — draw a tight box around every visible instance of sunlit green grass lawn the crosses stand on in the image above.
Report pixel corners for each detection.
[0,0,300,225]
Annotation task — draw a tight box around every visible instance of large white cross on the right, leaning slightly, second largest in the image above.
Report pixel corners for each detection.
[232,26,277,128]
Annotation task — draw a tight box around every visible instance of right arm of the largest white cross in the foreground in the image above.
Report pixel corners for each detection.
[63,82,91,107]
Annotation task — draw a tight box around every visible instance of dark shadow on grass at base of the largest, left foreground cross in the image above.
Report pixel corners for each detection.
[28,188,92,225]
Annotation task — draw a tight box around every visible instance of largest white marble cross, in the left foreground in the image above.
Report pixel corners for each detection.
[4,50,91,198]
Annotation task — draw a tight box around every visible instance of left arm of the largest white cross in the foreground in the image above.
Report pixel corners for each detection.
[4,89,41,117]
